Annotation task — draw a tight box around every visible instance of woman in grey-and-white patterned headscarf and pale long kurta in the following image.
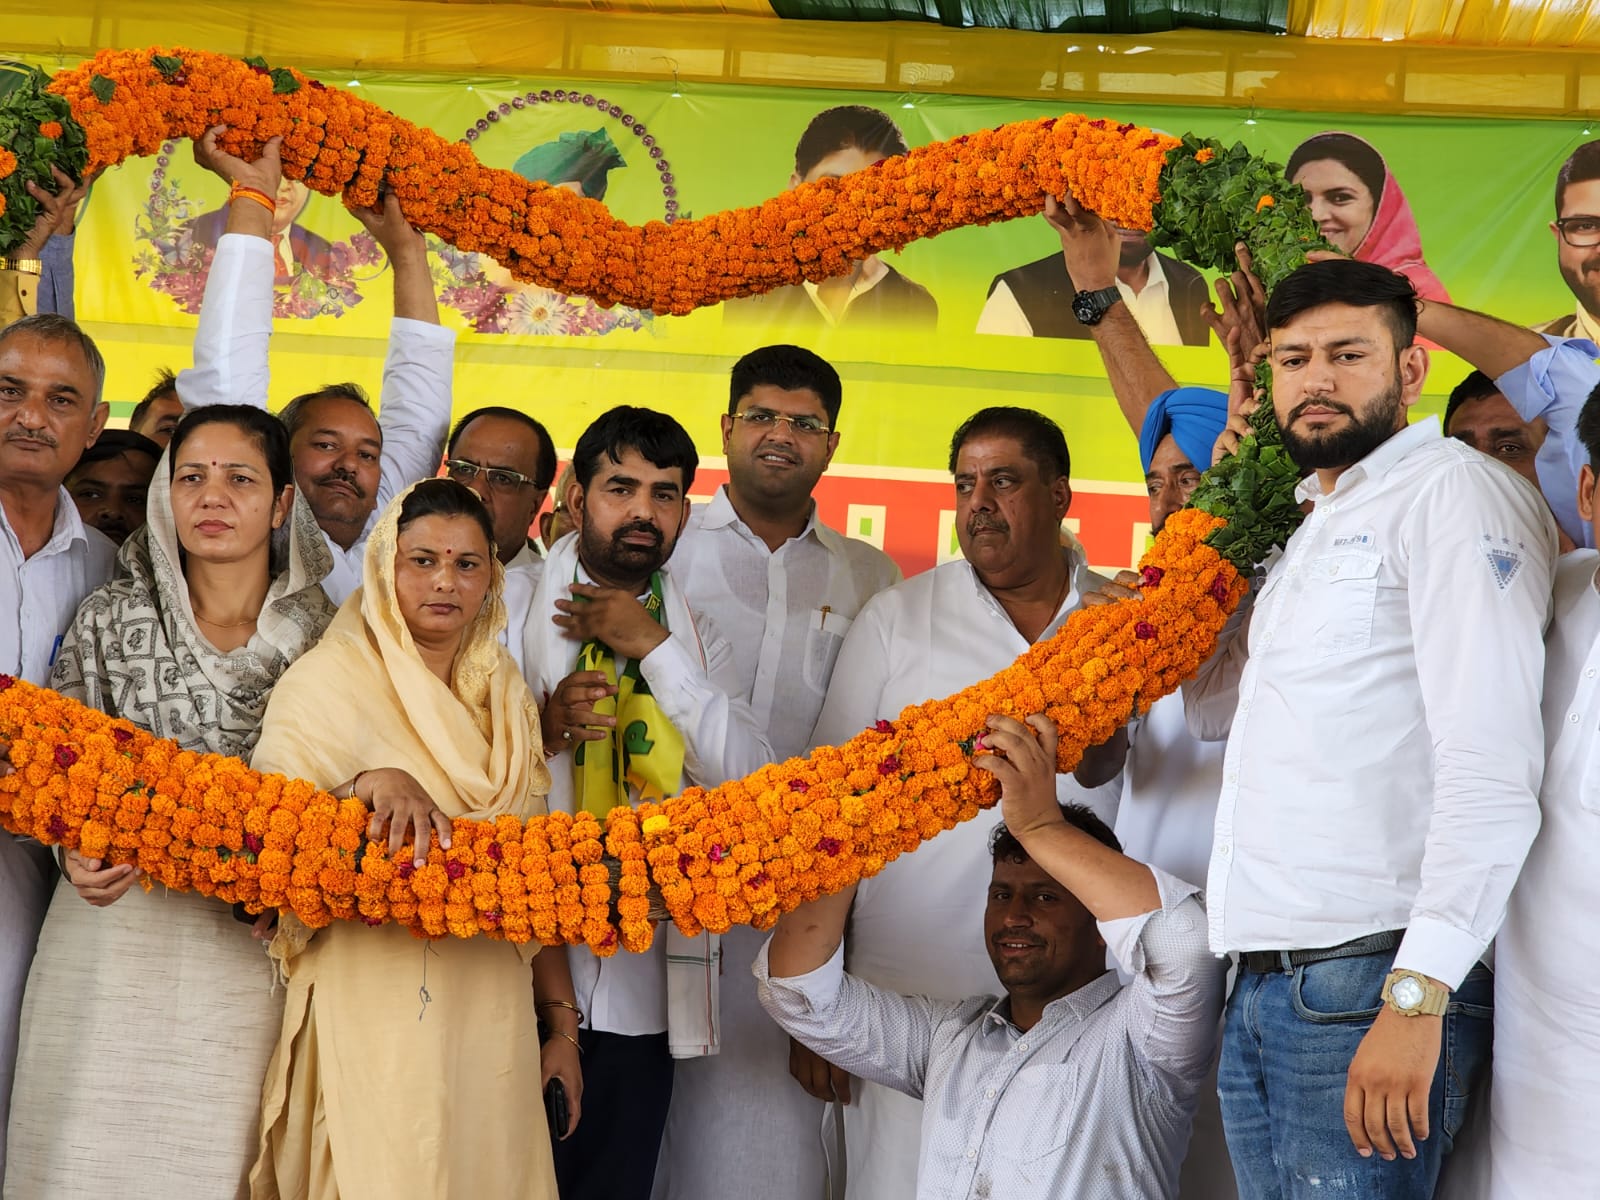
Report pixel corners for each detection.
[3,405,334,1200]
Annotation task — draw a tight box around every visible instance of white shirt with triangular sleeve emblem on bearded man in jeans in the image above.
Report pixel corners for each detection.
[1184,418,1557,987]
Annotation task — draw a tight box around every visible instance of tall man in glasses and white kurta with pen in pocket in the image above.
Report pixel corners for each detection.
[656,346,901,1200]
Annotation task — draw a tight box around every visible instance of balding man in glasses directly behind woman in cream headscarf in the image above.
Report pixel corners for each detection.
[445,405,555,566]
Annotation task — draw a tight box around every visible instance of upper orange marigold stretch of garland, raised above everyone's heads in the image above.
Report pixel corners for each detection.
[0,48,1317,314]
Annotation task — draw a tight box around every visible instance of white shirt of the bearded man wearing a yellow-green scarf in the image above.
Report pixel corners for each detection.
[514,533,773,1035]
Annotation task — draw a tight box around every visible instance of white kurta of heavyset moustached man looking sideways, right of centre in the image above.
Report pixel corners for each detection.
[813,550,1122,1200]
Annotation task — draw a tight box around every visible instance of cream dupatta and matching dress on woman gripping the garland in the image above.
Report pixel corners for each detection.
[251,480,570,1200]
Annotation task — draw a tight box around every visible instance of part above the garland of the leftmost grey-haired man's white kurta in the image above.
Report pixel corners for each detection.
[0,488,117,686]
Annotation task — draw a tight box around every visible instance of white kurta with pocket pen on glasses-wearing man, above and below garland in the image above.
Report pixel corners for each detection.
[654,486,899,1200]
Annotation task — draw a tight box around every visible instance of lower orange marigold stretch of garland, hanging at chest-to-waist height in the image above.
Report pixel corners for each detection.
[0,509,1245,954]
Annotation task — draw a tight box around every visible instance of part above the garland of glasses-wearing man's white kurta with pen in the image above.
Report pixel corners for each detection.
[672,486,901,758]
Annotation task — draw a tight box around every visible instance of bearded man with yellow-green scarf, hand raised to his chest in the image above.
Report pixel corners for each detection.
[514,406,773,1200]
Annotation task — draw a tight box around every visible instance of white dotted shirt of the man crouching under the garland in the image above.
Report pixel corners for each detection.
[755,870,1222,1200]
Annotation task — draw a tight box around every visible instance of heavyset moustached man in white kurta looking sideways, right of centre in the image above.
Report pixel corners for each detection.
[811,408,1120,1200]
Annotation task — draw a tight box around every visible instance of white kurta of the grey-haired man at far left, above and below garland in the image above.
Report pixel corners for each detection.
[0,488,117,1181]
